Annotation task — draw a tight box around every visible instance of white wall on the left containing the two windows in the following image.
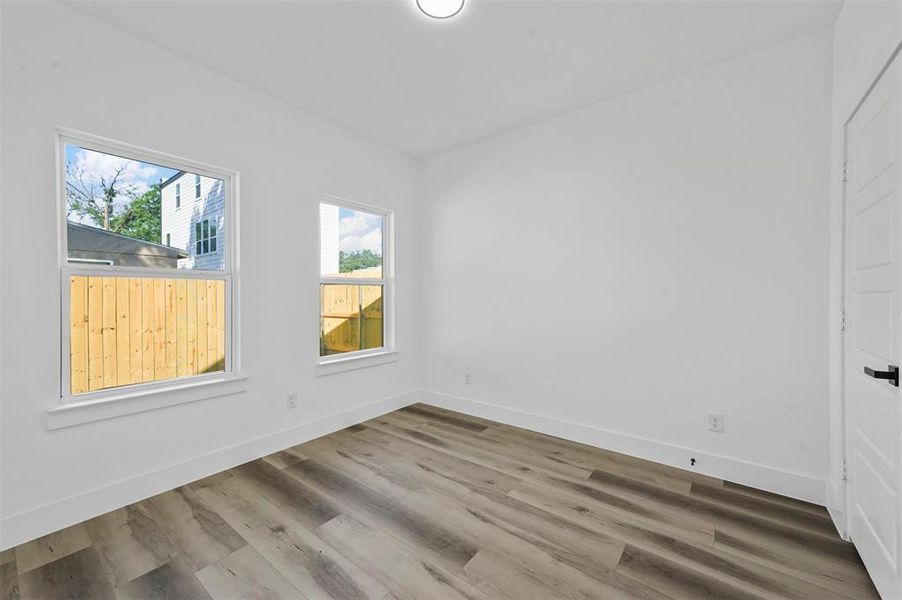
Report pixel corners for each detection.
[0,2,417,547]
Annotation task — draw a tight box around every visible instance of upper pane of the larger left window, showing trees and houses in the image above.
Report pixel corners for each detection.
[65,144,225,271]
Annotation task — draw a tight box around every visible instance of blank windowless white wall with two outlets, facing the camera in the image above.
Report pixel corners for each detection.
[420,32,832,502]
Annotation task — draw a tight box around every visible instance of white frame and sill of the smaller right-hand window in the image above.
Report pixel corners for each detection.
[316,194,399,376]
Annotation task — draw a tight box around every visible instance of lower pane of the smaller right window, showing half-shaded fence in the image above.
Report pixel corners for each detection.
[320,284,384,356]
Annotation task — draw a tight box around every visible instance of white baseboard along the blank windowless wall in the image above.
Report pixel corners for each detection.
[420,390,826,506]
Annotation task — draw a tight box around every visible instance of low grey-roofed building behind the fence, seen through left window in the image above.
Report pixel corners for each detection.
[66,221,188,269]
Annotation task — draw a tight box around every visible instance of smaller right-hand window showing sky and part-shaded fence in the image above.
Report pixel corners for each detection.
[320,202,391,361]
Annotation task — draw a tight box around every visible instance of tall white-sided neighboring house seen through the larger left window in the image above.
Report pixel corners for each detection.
[161,171,225,271]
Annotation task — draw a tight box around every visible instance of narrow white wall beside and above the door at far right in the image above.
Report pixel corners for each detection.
[826,0,902,536]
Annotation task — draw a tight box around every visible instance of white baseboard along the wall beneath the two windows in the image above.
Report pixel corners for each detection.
[0,390,418,550]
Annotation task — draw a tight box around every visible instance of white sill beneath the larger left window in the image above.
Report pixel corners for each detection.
[47,374,247,430]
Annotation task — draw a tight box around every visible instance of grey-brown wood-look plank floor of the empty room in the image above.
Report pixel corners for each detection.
[0,405,876,600]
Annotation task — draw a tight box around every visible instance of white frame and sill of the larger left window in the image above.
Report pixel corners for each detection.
[56,127,246,418]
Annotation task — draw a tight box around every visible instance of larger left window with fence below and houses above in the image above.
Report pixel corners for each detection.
[60,135,234,402]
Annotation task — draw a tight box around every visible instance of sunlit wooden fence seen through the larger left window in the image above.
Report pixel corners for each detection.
[69,275,226,394]
